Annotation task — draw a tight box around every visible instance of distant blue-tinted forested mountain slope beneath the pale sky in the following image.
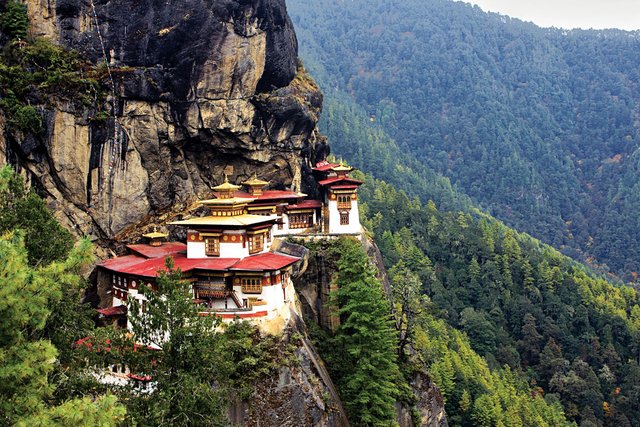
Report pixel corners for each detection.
[287,0,640,277]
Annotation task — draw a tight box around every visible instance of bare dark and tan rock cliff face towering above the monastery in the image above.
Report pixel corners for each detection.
[0,0,326,240]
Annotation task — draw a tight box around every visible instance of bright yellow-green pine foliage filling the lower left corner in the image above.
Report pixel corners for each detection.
[0,233,124,425]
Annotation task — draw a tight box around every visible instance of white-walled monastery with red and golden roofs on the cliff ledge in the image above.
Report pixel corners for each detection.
[98,162,362,327]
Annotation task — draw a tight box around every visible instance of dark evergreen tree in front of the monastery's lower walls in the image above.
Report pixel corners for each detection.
[122,258,232,426]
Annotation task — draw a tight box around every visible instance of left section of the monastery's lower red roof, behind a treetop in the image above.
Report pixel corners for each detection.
[100,253,239,278]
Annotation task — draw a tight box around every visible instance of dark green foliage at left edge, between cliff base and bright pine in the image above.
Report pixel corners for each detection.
[0,166,73,265]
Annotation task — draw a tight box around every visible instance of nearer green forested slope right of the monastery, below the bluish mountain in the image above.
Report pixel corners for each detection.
[359,177,640,425]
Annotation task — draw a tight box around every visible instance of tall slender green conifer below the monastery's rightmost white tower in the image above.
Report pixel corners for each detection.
[331,239,401,425]
